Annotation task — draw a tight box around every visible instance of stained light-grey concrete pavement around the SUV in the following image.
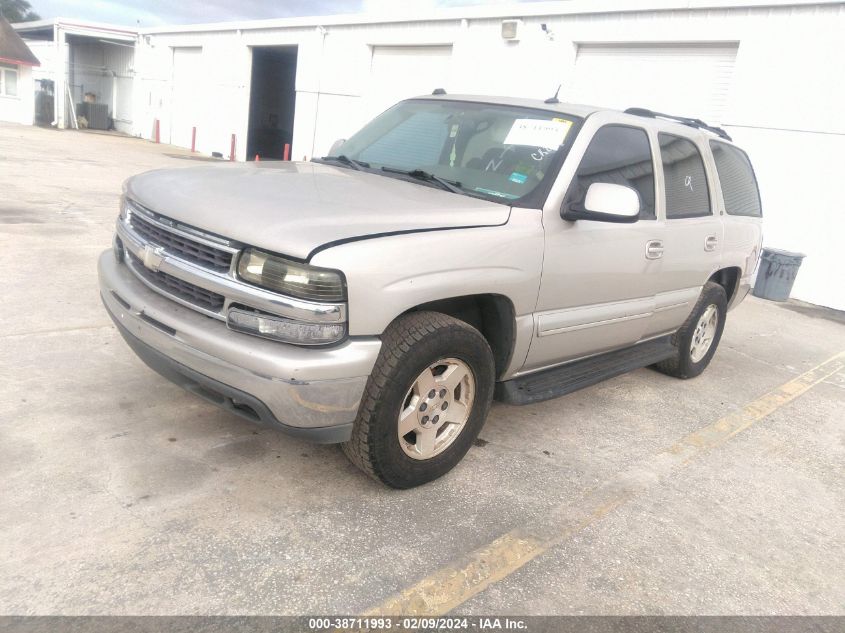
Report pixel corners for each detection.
[0,124,845,615]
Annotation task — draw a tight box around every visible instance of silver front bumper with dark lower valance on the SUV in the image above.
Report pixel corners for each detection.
[98,250,381,443]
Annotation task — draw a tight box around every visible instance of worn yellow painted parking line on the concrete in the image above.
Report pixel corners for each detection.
[364,351,845,615]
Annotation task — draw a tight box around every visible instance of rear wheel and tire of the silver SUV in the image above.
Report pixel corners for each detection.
[654,281,728,379]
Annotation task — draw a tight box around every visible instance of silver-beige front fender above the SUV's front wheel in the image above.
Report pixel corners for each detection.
[311,209,543,336]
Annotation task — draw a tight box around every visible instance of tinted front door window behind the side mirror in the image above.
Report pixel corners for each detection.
[567,125,654,219]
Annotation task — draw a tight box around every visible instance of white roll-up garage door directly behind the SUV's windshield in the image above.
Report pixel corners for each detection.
[367,46,452,116]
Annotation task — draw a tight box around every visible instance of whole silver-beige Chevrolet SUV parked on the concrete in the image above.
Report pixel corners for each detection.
[99,94,761,488]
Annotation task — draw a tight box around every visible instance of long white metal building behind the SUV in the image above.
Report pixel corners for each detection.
[14,0,845,309]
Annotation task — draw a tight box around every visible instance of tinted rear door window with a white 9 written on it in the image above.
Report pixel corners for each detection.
[657,134,710,220]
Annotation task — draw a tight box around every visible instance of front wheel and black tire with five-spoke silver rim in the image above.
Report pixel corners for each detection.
[343,312,495,488]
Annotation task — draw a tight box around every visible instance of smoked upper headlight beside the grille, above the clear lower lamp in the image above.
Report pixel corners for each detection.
[238,248,346,301]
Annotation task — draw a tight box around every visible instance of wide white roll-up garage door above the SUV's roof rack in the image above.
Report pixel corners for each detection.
[568,43,737,125]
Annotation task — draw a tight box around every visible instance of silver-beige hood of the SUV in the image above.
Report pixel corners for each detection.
[126,161,510,259]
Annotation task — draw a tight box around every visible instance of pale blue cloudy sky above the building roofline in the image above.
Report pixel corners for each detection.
[29,0,552,27]
